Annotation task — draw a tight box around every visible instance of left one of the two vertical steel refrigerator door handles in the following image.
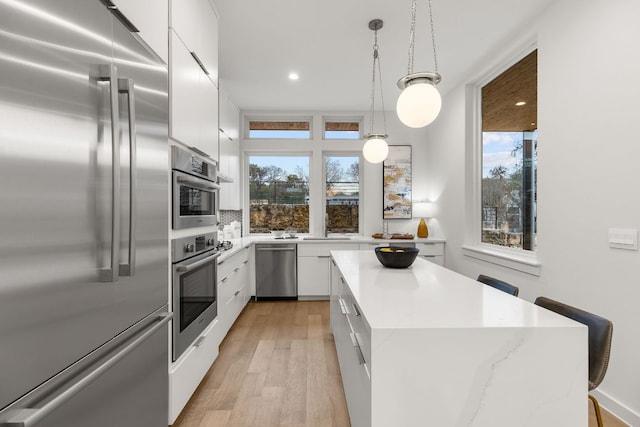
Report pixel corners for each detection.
[99,64,120,282]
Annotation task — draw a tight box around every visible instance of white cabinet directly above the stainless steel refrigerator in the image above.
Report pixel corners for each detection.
[113,0,169,63]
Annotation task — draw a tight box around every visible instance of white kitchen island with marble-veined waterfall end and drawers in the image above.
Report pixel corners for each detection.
[331,250,588,427]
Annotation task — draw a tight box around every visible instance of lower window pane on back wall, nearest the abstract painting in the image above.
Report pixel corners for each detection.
[324,154,360,233]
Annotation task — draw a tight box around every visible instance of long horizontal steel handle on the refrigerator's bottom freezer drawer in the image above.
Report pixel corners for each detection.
[0,313,173,427]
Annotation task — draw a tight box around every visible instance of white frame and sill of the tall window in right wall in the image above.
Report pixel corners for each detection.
[462,41,542,276]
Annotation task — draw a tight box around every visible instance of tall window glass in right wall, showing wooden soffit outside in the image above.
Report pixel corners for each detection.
[481,51,538,251]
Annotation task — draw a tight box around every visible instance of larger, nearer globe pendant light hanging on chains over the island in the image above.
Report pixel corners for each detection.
[396,0,442,128]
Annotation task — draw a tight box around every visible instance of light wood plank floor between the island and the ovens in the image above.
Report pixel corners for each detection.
[174,301,626,427]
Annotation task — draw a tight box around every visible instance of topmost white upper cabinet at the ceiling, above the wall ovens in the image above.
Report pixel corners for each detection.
[170,0,218,87]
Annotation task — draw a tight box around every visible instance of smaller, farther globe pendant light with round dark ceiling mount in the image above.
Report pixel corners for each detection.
[362,19,389,163]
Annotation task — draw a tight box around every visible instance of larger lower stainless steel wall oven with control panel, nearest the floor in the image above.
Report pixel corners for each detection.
[171,233,220,361]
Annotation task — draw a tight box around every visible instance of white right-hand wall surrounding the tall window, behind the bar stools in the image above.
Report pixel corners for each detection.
[424,0,640,425]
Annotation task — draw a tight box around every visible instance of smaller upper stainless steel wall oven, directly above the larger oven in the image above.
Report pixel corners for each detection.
[171,146,220,229]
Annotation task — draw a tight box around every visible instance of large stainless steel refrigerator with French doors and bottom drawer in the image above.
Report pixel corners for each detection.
[0,0,170,427]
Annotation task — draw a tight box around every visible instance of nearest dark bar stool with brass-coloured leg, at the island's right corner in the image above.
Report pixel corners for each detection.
[534,297,613,427]
